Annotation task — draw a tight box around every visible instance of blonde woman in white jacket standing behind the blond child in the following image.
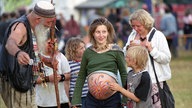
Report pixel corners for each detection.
[124,9,171,108]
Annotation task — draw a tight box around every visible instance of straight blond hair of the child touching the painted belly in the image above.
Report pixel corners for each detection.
[126,46,148,69]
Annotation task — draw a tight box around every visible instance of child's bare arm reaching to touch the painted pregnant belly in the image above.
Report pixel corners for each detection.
[109,83,140,102]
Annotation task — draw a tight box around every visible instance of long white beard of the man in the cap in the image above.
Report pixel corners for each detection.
[35,24,50,53]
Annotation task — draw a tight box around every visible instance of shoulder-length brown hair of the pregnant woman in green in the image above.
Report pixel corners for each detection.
[88,17,115,46]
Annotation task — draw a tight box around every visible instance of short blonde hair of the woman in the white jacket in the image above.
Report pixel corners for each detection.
[129,9,155,30]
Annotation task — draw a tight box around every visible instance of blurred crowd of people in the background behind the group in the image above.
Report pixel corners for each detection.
[0,4,192,54]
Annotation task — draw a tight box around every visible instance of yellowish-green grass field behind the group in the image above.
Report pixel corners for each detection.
[0,51,192,108]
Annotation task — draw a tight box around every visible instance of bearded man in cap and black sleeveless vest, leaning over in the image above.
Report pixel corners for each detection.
[1,1,55,108]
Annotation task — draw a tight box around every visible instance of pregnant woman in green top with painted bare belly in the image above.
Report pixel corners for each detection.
[72,18,127,108]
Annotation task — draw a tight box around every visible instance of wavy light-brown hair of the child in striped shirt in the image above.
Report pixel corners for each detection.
[65,37,85,60]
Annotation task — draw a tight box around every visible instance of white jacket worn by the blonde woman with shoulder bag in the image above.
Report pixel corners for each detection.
[123,27,171,83]
